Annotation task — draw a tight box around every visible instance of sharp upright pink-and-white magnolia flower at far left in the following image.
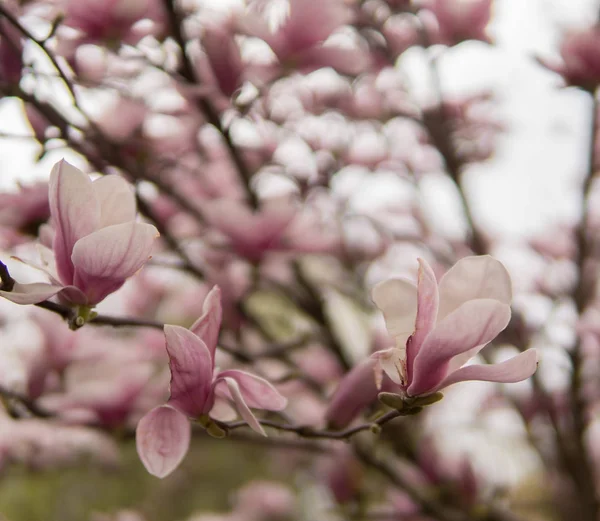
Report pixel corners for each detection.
[0,160,158,308]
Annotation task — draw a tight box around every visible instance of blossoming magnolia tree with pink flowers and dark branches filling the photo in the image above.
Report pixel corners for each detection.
[0,0,600,521]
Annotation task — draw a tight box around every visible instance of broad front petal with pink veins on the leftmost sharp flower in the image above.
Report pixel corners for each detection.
[71,222,158,282]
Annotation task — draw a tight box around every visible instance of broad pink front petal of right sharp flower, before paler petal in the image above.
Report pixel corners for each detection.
[408,299,510,396]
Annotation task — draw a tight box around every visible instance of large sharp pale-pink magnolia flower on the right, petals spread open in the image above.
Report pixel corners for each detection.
[327,255,537,426]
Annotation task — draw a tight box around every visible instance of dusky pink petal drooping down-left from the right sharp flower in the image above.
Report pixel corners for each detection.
[325,358,378,429]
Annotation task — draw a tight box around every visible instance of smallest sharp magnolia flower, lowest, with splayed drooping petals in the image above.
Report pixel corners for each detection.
[136,286,287,478]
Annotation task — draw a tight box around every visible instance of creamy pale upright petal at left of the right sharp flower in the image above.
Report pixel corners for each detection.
[371,279,417,344]
